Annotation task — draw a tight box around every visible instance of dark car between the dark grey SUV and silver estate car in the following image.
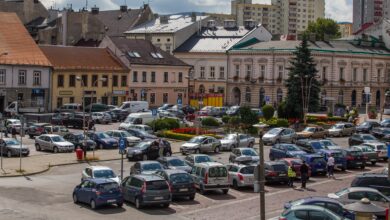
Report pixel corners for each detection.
[156,170,196,200]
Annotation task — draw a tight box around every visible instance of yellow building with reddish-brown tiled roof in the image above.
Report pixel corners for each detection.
[40,46,129,110]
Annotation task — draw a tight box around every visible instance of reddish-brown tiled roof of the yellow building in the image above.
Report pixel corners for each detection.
[40,46,127,71]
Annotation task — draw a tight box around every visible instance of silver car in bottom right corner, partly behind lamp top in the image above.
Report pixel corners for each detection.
[328,187,390,219]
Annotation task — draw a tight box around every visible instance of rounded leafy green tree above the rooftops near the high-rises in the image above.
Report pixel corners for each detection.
[305,18,341,40]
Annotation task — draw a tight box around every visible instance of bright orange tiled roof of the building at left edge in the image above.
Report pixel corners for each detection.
[0,12,51,66]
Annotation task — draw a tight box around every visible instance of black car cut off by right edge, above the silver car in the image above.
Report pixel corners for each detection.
[351,173,390,196]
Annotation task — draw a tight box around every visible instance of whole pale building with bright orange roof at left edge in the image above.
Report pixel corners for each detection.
[0,12,51,112]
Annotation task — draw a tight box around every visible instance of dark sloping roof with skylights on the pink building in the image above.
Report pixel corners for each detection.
[111,37,189,66]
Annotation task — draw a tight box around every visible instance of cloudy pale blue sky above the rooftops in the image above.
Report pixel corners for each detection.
[41,0,352,22]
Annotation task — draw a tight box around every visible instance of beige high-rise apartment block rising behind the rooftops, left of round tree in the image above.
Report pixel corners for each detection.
[231,0,325,36]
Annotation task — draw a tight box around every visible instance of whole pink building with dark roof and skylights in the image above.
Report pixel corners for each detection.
[100,37,191,107]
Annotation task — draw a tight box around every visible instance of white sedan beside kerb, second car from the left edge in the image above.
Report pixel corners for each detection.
[35,134,74,153]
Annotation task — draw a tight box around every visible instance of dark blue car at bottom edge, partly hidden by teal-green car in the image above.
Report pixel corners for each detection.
[284,197,353,219]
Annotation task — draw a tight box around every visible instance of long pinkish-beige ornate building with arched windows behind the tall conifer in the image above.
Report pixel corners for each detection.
[227,41,390,108]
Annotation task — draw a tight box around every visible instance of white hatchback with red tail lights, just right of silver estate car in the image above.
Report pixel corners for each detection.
[226,164,255,189]
